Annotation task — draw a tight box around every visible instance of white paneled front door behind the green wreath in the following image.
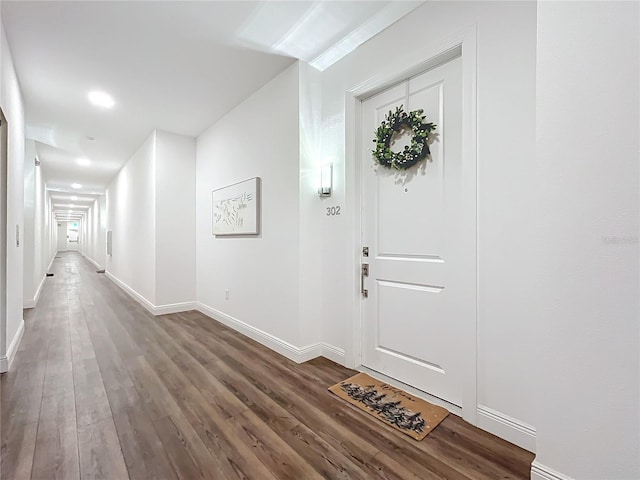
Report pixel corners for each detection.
[361,57,476,406]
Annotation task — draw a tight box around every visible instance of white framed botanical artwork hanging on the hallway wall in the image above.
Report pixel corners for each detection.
[212,177,260,236]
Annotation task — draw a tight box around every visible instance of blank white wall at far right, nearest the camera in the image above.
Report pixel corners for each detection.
[536,2,640,480]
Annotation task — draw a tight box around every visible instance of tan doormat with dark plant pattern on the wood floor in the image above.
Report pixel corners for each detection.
[329,373,449,441]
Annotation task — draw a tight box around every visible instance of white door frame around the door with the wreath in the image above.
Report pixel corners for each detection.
[345,25,478,425]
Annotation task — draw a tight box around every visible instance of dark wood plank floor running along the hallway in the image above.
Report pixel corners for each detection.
[1,253,533,480]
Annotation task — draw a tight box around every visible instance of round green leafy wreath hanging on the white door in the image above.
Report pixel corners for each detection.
[372,105,436,170]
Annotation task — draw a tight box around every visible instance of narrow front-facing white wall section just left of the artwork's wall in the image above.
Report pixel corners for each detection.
[156,130,196,305]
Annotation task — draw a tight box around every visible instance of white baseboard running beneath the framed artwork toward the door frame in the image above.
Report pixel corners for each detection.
[196,302,346,365]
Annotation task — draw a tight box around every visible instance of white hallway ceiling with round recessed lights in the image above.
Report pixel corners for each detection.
[1,0,422,221]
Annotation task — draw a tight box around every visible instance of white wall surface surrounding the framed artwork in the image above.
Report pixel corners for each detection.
[196,64,302,347]
